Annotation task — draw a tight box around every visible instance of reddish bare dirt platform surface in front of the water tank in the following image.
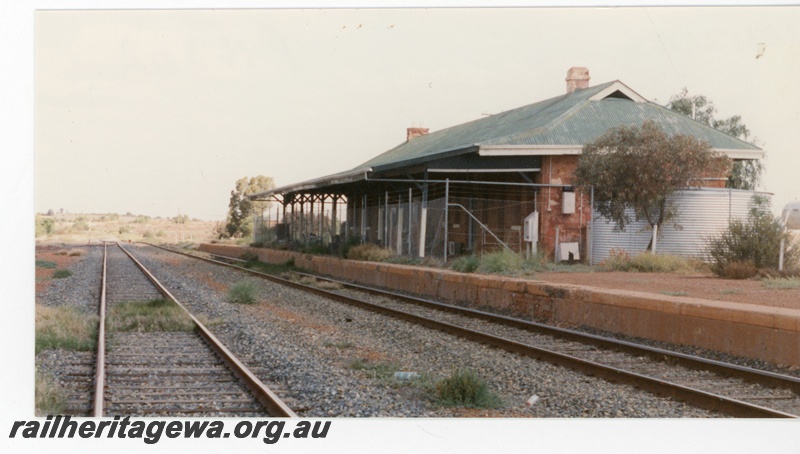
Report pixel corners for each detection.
[536,271,800,309]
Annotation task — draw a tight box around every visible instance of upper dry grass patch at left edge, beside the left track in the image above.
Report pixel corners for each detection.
[36,305,97,353]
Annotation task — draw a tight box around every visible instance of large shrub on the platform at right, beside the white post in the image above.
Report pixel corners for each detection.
[707,196,800,276]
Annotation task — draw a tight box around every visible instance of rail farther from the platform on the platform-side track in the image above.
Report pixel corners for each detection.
[147,245,798,418]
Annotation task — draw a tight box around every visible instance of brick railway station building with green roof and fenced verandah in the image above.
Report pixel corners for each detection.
[249,67,764,263]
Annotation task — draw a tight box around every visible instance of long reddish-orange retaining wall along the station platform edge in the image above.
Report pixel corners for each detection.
[199,244,800,367]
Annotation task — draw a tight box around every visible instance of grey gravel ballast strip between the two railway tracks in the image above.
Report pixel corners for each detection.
[126,246,718,418]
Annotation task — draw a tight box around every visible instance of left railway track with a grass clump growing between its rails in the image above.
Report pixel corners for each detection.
[83,244,297,417]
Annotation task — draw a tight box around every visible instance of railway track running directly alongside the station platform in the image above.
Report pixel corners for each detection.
[152,246,800,418]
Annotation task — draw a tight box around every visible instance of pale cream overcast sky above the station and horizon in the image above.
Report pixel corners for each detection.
[25,7,800,220]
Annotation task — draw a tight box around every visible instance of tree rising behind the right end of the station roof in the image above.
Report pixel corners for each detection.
[667,88,764,190]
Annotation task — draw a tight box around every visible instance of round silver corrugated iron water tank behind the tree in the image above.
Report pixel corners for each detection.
[592,188,771,264]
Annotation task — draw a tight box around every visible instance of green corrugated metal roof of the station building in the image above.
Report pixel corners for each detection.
[354,81,759,170]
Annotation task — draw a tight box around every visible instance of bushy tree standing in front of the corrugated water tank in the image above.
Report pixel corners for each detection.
[575,121,730,250]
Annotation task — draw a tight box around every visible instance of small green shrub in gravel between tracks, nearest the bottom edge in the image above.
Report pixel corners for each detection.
[435,369,502,408]
